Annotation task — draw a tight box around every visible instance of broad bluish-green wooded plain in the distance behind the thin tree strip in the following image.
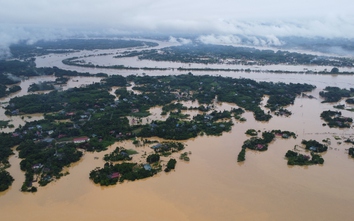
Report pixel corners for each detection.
[126,44,353,67]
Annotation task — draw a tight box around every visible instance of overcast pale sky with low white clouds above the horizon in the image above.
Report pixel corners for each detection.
[0,0,354,53]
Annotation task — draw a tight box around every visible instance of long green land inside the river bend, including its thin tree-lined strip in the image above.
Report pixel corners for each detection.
[62,44,353,74]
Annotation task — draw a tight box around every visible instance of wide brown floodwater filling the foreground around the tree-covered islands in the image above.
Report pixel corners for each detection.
[0,41,354,221]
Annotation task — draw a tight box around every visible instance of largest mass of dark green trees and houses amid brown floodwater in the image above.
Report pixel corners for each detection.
[0,71,314,191]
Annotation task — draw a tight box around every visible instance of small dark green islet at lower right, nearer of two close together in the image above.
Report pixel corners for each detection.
[285,150,324,166]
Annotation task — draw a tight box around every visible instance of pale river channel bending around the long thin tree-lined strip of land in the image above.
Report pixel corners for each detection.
[36,38,354,75]
